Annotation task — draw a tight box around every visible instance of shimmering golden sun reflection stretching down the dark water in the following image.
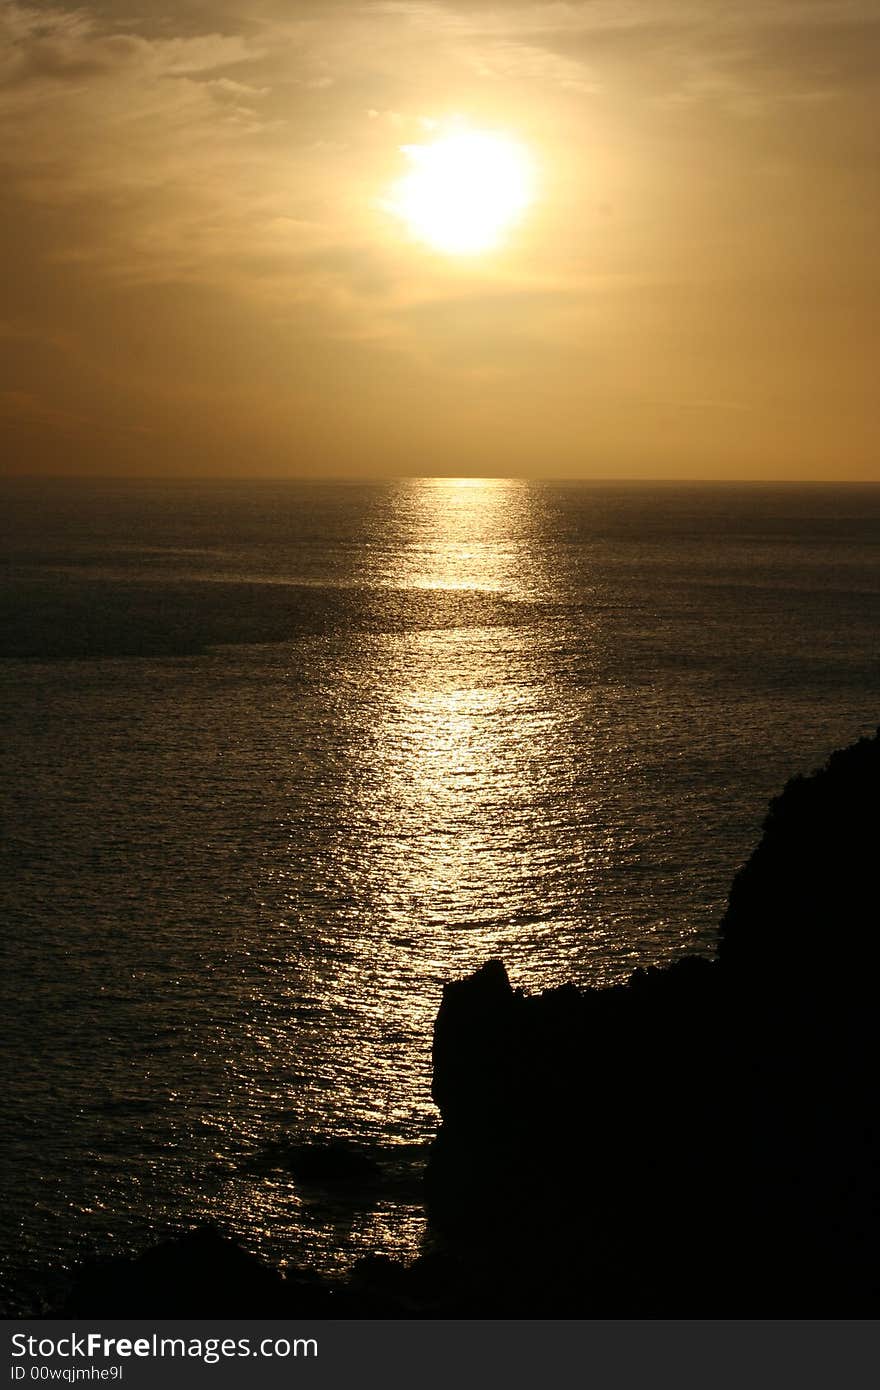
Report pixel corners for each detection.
[236,478,628,1278]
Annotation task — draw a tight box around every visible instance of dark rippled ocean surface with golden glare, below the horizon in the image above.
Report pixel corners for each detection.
[0,480,880,1307]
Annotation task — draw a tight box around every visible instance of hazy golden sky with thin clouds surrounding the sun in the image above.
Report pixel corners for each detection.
[0,0,880,480]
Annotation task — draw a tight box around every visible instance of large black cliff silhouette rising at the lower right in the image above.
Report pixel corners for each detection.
[428,737,880,1316]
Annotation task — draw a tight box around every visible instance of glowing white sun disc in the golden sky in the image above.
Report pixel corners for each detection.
[385,131,532,256]
